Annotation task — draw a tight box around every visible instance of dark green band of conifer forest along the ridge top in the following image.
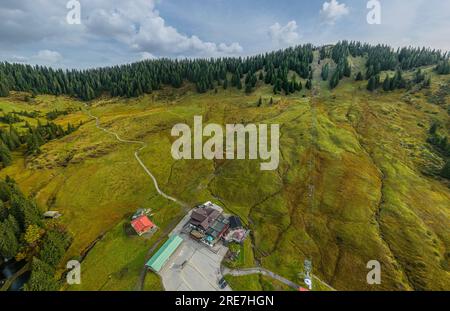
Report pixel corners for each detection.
[0,41,450,101]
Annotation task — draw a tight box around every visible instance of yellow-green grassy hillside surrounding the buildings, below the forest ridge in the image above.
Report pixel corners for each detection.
[0,44,450,290]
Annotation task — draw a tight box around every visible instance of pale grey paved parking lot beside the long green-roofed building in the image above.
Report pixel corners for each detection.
[159,234,231,291]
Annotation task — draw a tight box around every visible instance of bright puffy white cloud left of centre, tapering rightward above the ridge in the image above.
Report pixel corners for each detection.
[86,0,243,57]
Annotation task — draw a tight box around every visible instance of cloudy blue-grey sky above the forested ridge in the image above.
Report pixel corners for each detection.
[0,0,450,68]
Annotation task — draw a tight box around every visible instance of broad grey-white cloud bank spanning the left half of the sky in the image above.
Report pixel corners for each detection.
[0,0,243,57]
